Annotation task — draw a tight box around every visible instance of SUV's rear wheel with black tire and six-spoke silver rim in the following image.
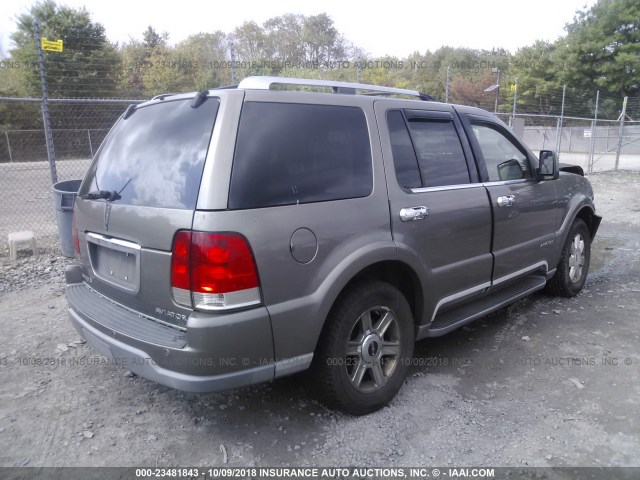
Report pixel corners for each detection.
[313,281,414,415]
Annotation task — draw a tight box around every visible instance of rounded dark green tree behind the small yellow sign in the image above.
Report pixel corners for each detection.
[11,0,120,97]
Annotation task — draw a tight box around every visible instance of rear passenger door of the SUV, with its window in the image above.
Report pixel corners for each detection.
[375,101,492,322]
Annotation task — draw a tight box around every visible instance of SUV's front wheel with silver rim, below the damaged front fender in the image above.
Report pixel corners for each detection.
[545,218,591,297]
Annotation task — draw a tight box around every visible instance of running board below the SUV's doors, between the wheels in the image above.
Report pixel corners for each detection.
[416,275,546,340]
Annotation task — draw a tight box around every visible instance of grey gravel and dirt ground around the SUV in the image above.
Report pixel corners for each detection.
[0,172,640,466]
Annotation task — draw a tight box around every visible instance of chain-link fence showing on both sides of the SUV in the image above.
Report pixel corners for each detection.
[0,88,640,249]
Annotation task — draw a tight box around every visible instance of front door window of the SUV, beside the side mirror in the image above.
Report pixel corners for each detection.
[471,122,532,182]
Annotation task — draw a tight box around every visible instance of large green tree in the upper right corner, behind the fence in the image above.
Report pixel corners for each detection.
[509,0,640,118]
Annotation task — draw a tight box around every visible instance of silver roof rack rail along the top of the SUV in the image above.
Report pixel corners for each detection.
[238,77,433,101]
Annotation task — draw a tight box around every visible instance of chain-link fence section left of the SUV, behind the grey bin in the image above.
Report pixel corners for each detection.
[0,98,139,243]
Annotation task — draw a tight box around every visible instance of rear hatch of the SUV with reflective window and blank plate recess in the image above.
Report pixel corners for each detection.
[75,96,220,327]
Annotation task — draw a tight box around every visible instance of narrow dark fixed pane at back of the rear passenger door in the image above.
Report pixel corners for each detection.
[387,110,422,188]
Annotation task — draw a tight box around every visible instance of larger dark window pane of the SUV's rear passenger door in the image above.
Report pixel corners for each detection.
[409,119,469,187]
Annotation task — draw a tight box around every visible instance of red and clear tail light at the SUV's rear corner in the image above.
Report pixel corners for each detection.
[171,231,260,310]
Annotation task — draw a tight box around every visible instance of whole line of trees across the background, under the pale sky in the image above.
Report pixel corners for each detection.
[0,0,640,116]
